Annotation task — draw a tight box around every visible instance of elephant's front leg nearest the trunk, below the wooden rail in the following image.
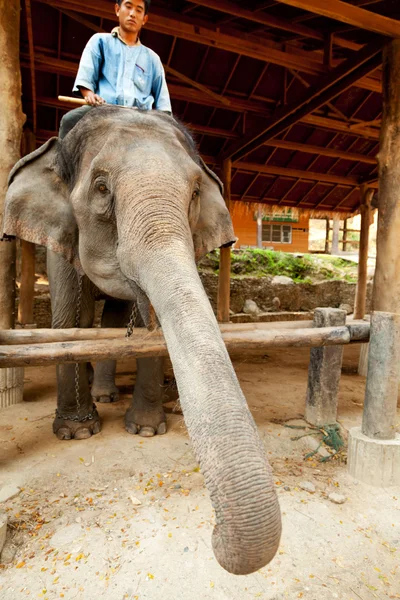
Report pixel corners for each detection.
[125,357,167,437]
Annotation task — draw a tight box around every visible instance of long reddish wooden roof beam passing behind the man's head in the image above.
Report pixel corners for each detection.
[33,0,380,91]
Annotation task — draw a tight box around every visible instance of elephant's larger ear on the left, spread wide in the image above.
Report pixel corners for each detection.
[3,138,80,269]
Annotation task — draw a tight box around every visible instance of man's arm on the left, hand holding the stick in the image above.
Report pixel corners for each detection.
[73,34,104,106]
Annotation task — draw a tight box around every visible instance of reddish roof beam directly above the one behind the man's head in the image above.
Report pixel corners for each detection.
[189,0,361,50]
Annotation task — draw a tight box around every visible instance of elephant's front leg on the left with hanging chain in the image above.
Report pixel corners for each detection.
[47,251,101,440]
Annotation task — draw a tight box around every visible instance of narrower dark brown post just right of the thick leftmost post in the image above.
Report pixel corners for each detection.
[18,129,36,326]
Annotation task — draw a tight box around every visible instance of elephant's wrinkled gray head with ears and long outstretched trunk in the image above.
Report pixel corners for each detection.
[4,107,281,574]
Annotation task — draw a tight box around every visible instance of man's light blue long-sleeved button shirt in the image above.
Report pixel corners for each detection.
[73,28,172,112]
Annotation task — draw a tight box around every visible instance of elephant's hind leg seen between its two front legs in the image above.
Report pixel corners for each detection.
[92,298,132,402]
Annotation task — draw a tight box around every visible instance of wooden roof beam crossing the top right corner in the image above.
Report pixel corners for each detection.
[279,0,400,38]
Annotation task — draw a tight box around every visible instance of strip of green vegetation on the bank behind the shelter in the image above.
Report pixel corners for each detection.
[199,248,357,283]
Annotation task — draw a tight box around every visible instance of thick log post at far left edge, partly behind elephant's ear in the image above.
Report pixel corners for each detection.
[0,0,24,407]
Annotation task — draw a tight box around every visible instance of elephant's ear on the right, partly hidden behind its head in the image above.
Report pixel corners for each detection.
[193,158,237,260]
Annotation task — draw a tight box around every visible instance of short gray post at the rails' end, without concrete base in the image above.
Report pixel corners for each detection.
[305,308,346,427]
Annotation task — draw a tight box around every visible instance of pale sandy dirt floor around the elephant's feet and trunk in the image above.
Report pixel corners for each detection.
[0,346,400,600]
